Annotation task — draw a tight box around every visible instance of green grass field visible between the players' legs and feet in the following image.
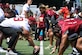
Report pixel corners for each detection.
[0,40,71,55]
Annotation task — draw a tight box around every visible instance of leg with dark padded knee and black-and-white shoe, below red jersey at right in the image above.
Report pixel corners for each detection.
[68,33,78,55]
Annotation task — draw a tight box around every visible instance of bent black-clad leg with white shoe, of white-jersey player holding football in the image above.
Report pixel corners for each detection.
[2,27,18,54]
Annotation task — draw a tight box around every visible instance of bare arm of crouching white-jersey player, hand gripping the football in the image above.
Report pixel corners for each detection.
[22,27,40,55]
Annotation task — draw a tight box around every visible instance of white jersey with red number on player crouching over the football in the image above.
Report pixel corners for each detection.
[0,17,30,31]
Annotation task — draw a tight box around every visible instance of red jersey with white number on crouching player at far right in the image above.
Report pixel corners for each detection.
[58,18,82,34]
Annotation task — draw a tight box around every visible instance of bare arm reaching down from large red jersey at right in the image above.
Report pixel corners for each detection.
[58,34,69,55]
